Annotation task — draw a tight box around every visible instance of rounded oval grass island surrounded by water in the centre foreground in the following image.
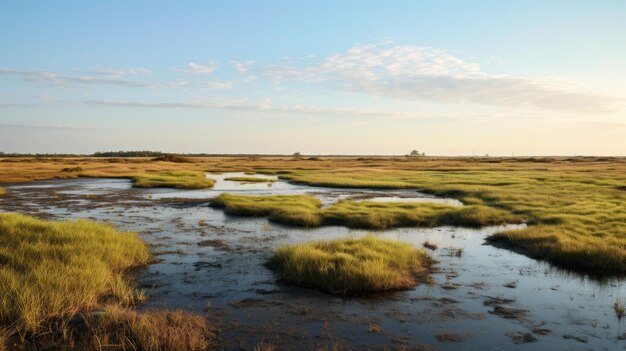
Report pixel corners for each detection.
[268,236,431,295]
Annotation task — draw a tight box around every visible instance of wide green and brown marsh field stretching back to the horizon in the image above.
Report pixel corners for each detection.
[0,156,626,272]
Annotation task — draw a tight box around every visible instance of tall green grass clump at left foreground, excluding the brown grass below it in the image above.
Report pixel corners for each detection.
[0,213,150,338]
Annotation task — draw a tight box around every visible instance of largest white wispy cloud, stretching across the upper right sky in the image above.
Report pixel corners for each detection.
[263,45,624,112]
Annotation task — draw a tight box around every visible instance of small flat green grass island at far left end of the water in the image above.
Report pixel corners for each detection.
[133,171,215,189]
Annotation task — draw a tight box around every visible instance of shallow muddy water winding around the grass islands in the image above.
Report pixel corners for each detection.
[0,173,626,351]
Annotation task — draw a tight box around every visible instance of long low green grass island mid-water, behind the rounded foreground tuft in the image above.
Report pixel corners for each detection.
[211,193,523,229]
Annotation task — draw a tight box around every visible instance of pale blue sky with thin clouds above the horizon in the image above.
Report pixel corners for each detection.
[0,0,626,156]
